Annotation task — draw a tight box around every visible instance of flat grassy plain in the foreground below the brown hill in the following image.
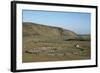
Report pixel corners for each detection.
[23,38,91,62]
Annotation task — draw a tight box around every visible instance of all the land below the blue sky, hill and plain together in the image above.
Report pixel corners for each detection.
[22,23,91,63]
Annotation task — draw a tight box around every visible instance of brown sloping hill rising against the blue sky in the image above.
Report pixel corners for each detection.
[23,22,78,40]
